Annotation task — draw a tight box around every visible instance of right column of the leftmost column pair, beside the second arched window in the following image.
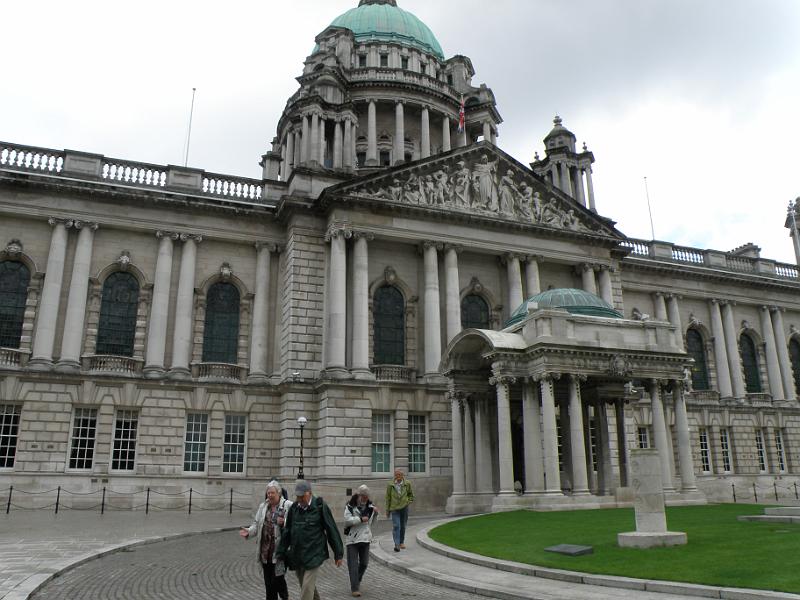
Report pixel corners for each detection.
[56,221,97,372]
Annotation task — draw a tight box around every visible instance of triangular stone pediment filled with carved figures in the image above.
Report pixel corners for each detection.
[324,142,624,238]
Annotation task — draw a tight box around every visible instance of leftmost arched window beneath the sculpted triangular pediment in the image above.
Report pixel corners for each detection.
[372,285,406,365]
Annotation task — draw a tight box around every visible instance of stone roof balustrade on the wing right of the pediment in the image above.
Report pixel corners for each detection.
[620,238,800,279]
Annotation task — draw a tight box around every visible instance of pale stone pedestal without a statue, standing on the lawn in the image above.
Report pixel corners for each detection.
[617,449,686,548]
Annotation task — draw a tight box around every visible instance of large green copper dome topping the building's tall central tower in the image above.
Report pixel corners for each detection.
[314,0,444,60]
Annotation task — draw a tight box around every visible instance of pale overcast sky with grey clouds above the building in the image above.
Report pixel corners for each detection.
[6,0,800,262]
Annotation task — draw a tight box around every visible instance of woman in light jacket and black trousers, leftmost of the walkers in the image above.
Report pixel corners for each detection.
[239,480,292,600]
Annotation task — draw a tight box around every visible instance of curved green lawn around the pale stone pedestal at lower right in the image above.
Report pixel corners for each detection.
[430,504,800,593]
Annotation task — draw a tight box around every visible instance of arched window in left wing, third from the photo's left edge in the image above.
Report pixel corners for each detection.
[203,282,239,364]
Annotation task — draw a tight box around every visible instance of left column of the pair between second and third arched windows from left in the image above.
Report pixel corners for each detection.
[144,231,178,379]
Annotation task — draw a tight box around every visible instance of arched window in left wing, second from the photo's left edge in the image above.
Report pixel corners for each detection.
[95,273,139,356]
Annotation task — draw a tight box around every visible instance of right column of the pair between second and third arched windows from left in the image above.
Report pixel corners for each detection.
[169,233,203,379]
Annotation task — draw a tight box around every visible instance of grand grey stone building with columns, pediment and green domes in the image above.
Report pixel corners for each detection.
[0,0,800,512]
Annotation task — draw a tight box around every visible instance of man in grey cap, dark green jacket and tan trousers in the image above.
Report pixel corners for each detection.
[275,479,344,600]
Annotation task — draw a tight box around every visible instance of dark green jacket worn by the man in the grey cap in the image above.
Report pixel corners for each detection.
[276,496,344,570]
